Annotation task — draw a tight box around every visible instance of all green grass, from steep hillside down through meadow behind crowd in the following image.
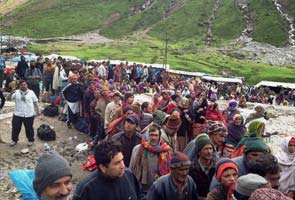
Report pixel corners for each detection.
[0,0,295,84]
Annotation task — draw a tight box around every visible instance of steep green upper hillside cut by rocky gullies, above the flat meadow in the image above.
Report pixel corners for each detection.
[1,0,295,46]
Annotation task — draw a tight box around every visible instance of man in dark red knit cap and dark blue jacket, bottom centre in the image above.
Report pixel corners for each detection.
[146,152,198,200]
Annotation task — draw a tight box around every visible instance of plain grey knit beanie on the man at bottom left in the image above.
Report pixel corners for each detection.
[33,151,72,195]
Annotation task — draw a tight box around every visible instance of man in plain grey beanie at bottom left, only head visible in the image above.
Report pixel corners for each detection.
[33,151,73,200]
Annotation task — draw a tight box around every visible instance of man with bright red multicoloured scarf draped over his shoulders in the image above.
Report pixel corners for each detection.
[129,124,171,192]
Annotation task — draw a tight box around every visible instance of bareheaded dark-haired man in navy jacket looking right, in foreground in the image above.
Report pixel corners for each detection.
[73,140,142,200]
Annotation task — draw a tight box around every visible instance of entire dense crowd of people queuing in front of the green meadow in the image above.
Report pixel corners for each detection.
[1,54,295,200]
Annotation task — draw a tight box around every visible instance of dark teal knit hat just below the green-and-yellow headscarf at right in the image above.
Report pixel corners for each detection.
[244,137,269,154]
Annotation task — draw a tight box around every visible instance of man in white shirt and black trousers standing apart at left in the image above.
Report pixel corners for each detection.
[10,80,39,146]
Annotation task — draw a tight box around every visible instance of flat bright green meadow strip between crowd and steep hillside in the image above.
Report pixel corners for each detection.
[29,41,295,84]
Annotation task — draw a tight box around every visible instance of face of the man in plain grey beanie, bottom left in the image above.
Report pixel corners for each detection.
[41,176,73,200]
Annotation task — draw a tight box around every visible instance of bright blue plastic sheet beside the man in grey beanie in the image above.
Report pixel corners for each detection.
[8,169,40,200]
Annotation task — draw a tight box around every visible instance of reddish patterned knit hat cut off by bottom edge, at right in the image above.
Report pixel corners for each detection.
[249,188,291,200]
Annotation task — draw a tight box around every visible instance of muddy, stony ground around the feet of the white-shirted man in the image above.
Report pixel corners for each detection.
[0,102,91,200]
